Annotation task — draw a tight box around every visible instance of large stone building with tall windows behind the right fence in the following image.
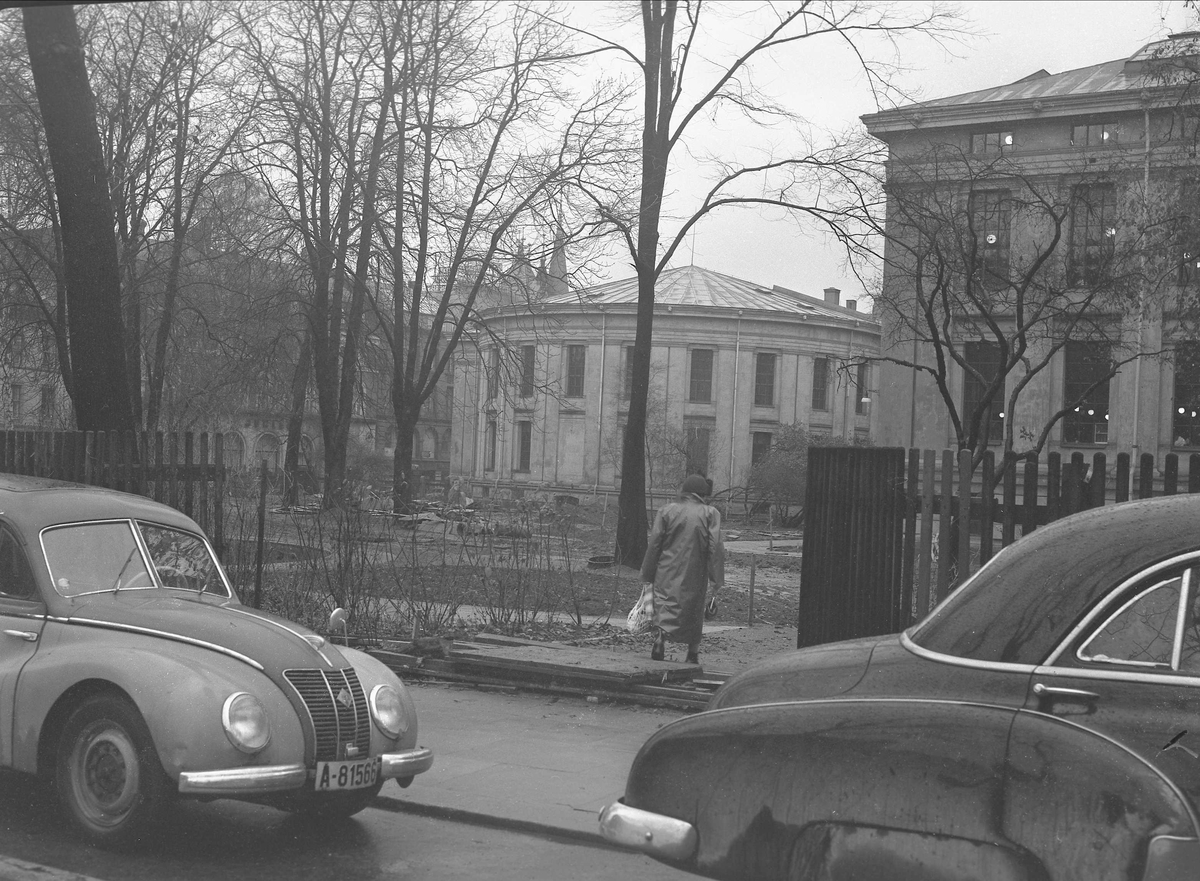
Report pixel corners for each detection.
[863,34,1200,461]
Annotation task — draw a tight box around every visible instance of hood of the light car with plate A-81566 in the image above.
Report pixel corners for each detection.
[68,591,348,679]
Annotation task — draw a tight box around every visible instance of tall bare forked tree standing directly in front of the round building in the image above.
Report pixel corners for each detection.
[580,0,953,565]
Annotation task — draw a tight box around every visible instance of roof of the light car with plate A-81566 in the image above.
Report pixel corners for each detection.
[0,474,200,532]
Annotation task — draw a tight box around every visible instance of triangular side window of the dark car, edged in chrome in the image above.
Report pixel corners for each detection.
[1079,574,1180,670]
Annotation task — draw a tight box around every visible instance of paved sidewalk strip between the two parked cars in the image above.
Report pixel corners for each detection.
[376,683,683,844]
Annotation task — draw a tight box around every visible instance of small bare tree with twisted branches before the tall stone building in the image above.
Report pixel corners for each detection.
[876,145,1194,484]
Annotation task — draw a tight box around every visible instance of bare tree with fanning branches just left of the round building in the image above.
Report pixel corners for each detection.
[380,1,624,510]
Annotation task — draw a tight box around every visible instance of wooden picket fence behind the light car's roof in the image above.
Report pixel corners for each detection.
[0,431,226,555]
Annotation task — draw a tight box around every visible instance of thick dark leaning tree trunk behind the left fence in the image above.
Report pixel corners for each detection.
[22,6,134,431]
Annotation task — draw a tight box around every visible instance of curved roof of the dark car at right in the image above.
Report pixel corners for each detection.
[912,495,1200,664]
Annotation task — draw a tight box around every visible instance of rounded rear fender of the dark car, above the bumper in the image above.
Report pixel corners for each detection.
[625,699,1192,881]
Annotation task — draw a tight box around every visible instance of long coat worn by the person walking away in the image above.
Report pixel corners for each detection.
[642,493,725,646]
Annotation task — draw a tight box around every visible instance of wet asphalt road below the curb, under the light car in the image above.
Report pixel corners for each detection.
[0,772,695,881]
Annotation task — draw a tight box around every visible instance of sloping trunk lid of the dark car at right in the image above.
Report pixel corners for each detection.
[708,636,894,709]
